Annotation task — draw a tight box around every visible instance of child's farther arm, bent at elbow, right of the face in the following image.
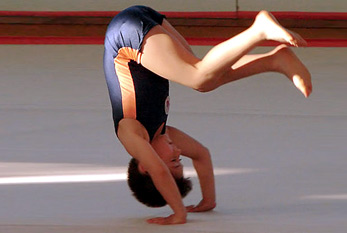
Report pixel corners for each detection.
[167,126,216,212]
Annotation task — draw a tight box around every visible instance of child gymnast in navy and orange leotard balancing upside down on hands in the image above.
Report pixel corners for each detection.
[104,6,312,225]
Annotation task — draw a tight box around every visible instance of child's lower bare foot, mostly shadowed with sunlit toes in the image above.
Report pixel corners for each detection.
[273,45,312,98]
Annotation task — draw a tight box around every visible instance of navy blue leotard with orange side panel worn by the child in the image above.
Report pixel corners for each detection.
[104,6,169,140]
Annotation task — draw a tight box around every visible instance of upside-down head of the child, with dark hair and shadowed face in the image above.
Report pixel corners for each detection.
[128,134,192,207]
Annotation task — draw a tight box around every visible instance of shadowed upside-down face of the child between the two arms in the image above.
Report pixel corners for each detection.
[151,134,183,178]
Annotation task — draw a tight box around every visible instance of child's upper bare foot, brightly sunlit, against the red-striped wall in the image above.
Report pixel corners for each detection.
[253,11,307,47]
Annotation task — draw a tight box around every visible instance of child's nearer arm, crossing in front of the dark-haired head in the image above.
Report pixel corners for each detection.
[118,119,187,224]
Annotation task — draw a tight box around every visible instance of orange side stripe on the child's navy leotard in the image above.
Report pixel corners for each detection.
[114,47,141,119]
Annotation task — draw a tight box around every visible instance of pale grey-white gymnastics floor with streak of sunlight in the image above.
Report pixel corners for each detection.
[0,45,347,233]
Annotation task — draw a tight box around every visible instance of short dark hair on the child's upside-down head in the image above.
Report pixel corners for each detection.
[128,158,192,207]
